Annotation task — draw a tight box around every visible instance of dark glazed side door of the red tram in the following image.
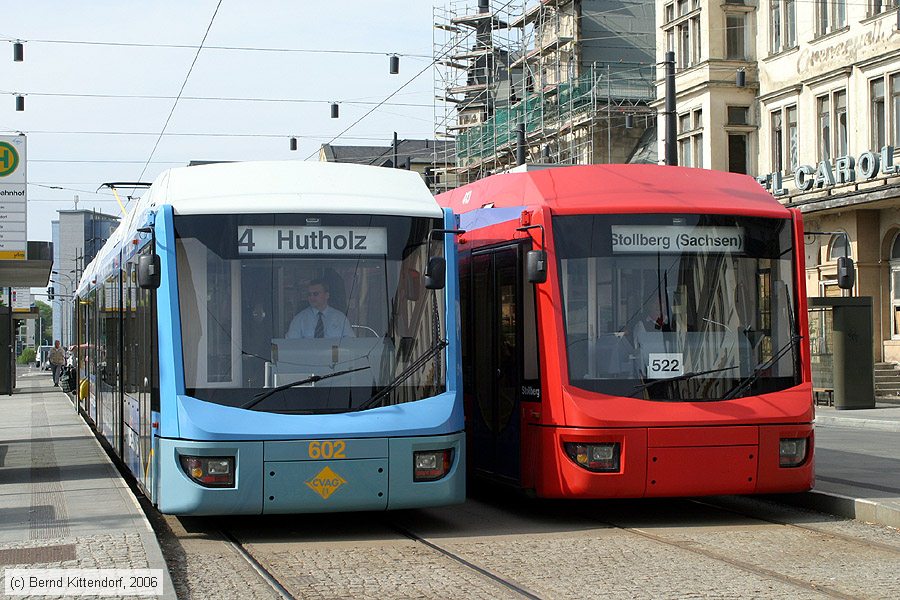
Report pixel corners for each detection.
[468,245,522,482]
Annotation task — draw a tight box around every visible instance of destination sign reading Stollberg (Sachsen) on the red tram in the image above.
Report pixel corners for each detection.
[612,225,744,254]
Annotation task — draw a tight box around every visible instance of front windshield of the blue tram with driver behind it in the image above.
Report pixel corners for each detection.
[175,214,446,414]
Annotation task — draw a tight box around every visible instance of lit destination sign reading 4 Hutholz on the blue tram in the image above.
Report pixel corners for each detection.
[237,225,387,256]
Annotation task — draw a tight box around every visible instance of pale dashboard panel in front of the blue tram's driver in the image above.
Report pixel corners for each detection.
[272,337,390,387]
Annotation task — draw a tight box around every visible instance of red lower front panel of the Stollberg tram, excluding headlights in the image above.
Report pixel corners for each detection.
[535,424,814,498]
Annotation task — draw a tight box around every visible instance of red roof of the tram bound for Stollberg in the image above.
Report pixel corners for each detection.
[438,165,789,218]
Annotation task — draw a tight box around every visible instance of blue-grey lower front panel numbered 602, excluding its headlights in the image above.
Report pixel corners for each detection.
[158,432,465,515]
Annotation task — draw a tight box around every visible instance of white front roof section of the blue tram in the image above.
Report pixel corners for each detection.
[145,161,443,218]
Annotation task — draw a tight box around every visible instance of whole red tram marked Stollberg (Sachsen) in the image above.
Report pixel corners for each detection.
[438,165,814,498]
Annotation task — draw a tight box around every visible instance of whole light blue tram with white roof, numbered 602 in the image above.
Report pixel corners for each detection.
[76,162,466,515]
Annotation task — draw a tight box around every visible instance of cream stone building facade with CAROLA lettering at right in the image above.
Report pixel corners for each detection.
[656,0,900,362]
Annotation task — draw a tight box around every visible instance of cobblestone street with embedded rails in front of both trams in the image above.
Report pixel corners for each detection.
[156,494,900,599]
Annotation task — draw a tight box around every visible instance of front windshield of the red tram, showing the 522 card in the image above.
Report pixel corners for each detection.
[553,214,800,402]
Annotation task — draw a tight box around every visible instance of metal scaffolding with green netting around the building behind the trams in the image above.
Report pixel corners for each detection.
[434,0,655,184]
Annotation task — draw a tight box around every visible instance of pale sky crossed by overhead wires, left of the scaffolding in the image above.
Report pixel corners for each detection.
[0,0,442,241]
